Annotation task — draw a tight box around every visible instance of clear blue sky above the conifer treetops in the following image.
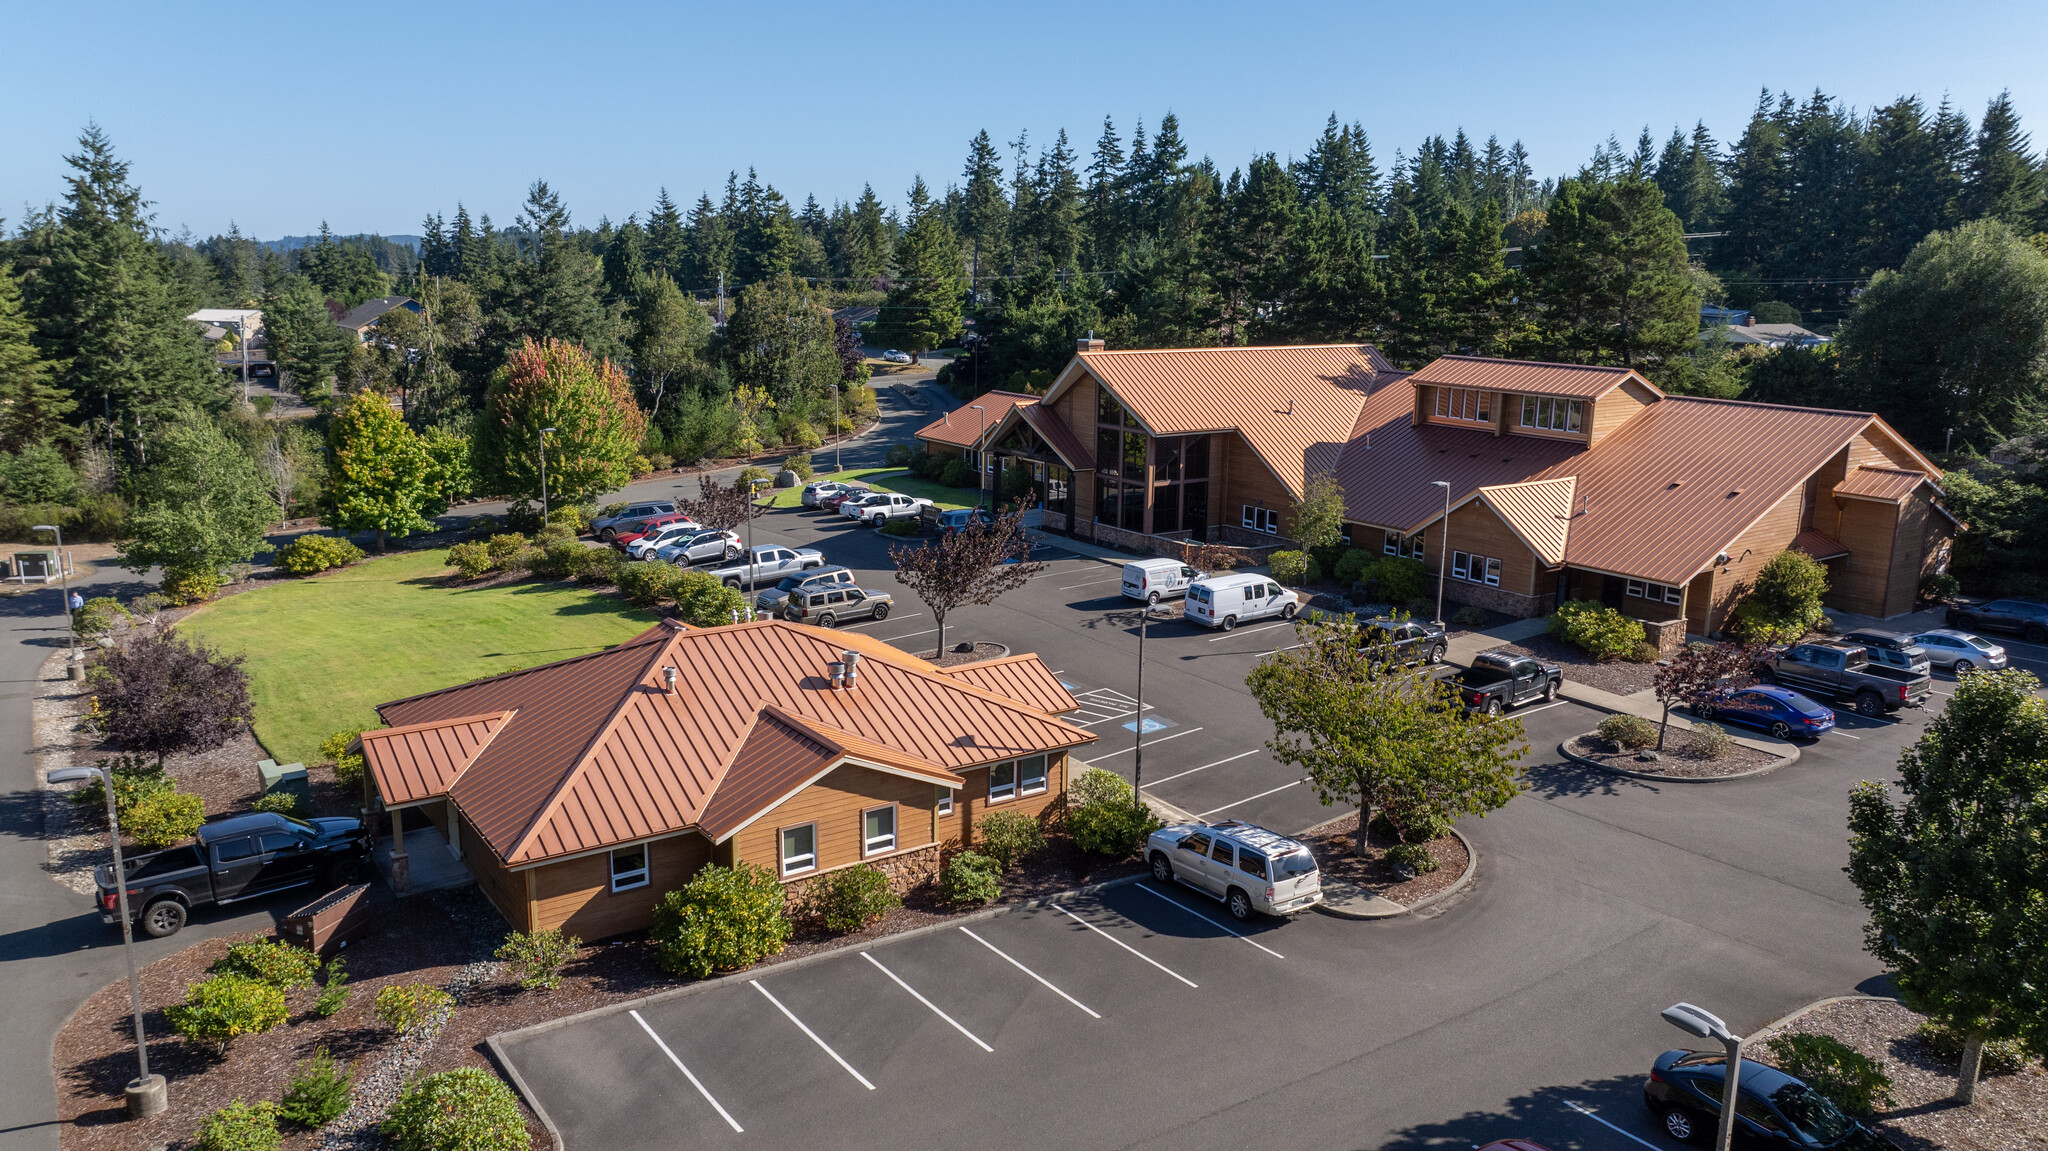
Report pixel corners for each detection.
[0,0,2048,238]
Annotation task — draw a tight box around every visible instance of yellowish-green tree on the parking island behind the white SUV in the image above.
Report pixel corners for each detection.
[1245,619,1528,856]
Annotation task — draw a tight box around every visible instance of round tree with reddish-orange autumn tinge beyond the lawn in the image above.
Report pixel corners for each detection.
[471,338,647,504]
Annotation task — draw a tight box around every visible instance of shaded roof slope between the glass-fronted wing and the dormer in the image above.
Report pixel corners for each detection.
[1337,385,1585,532]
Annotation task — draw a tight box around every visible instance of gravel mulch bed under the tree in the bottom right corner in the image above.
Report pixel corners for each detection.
[1757,999,2048,1151]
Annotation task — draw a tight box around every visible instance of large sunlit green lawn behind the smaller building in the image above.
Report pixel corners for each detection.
[180,549,655,764]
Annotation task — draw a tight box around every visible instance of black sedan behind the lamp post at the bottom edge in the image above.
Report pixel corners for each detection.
[1642,1051,1896,1151]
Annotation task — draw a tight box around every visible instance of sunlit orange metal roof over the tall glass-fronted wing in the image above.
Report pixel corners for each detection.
[1047,344,1397,498]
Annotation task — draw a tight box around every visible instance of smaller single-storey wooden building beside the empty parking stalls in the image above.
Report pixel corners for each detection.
[362,621,1096,940]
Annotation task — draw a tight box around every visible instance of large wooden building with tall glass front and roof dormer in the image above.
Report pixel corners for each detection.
[918,340,1954,634]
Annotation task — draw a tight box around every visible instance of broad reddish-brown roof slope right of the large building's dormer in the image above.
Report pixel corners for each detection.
[1544,395,1874,584]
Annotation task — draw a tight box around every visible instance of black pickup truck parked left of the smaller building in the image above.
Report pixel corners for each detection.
[92,811,369,938]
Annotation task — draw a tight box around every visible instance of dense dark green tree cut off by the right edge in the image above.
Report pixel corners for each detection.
[1849,668,2048,1104]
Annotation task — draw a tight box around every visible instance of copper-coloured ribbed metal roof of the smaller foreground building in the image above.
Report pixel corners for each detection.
[377,621,1096,864]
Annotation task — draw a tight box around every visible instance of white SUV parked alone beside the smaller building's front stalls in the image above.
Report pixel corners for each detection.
[1145,819,1323,920]
